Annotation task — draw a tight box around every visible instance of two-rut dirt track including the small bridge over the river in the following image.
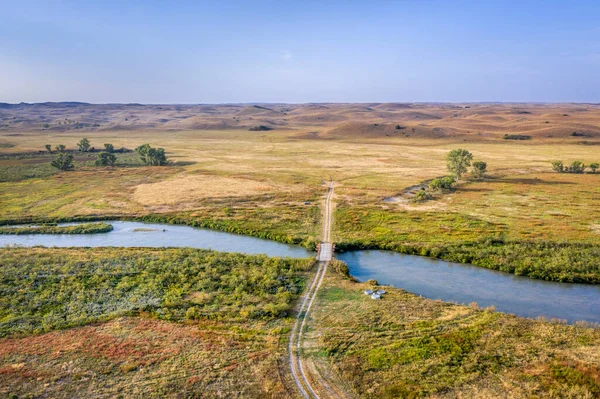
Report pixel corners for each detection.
[288,182,337,399]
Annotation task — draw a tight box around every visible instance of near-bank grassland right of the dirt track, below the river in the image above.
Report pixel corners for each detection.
[304,273,600,398]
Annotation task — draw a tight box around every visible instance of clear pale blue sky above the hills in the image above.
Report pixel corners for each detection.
[0,0,600,104]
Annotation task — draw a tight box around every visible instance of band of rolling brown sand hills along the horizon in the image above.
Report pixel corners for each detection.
[0,102,600,144]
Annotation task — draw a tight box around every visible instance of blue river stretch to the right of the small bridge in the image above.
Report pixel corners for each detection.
[337,251,600,323]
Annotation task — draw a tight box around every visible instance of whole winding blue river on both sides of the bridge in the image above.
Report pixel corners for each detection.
[0,221,600,323]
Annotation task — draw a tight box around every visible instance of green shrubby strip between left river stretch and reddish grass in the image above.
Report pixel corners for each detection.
[0,248,314,336]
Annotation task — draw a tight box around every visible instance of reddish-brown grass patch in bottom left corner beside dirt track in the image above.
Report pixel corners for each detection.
[0,317,295,399]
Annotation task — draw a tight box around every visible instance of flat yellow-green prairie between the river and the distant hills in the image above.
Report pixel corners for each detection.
[0,128,600,268]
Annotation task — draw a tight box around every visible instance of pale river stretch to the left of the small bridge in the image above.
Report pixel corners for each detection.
[0,221,314,258]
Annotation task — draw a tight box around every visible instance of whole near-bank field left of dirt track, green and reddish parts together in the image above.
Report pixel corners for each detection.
[0,248,313,398]
